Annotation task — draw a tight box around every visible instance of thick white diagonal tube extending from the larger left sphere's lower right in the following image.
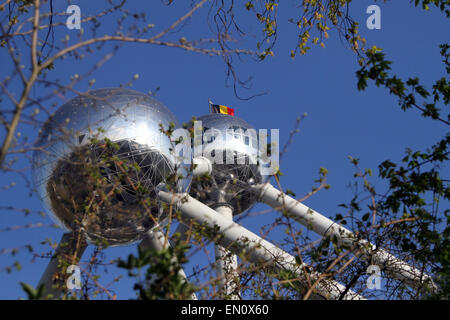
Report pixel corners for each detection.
[158,191,364,300]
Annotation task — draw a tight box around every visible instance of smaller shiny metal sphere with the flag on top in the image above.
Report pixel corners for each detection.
[190,114,264,215]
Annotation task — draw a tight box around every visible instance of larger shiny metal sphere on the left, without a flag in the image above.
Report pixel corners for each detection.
[32,88,184,246]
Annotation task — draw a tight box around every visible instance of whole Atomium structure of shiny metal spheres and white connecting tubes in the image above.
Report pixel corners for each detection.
[32,89,431,299]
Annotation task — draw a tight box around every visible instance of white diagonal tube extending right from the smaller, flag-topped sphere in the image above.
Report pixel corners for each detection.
[253,183,434,287]
